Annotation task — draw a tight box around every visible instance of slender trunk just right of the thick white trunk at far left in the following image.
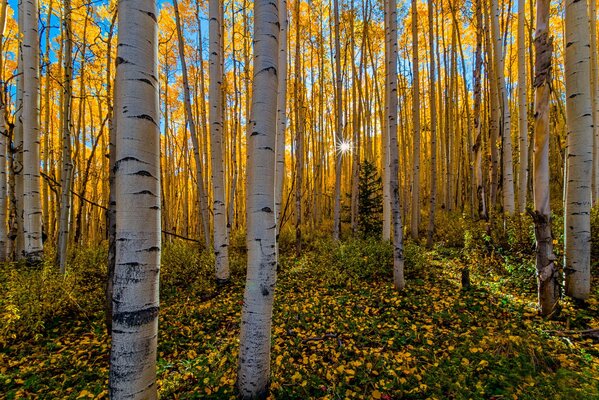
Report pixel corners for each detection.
[57,0,73,274]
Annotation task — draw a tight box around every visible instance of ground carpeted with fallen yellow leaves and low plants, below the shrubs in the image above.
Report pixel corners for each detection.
[0,228,599,399]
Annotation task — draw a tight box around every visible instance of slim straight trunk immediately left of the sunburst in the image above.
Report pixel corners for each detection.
[333,0,343,240]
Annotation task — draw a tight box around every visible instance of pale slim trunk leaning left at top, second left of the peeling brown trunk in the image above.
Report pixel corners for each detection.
[491,0,515,215]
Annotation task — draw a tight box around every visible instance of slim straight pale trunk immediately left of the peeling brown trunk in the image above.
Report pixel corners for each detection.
[518,0,528,213]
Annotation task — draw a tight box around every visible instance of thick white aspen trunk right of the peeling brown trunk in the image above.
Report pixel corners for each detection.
[565,0,595,300]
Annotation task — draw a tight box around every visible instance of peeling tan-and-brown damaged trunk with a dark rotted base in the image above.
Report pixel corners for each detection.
[532,0,559,316]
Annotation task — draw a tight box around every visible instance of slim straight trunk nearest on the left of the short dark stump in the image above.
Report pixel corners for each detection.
[426,0,437,248]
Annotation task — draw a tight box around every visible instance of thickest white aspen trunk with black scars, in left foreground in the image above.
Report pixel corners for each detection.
[109,0,161,399]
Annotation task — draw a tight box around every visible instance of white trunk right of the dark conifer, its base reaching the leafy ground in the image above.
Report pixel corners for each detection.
[385,0,406,290]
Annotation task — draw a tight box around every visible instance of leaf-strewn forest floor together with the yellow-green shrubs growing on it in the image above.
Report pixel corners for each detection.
[0,219,599,399]
